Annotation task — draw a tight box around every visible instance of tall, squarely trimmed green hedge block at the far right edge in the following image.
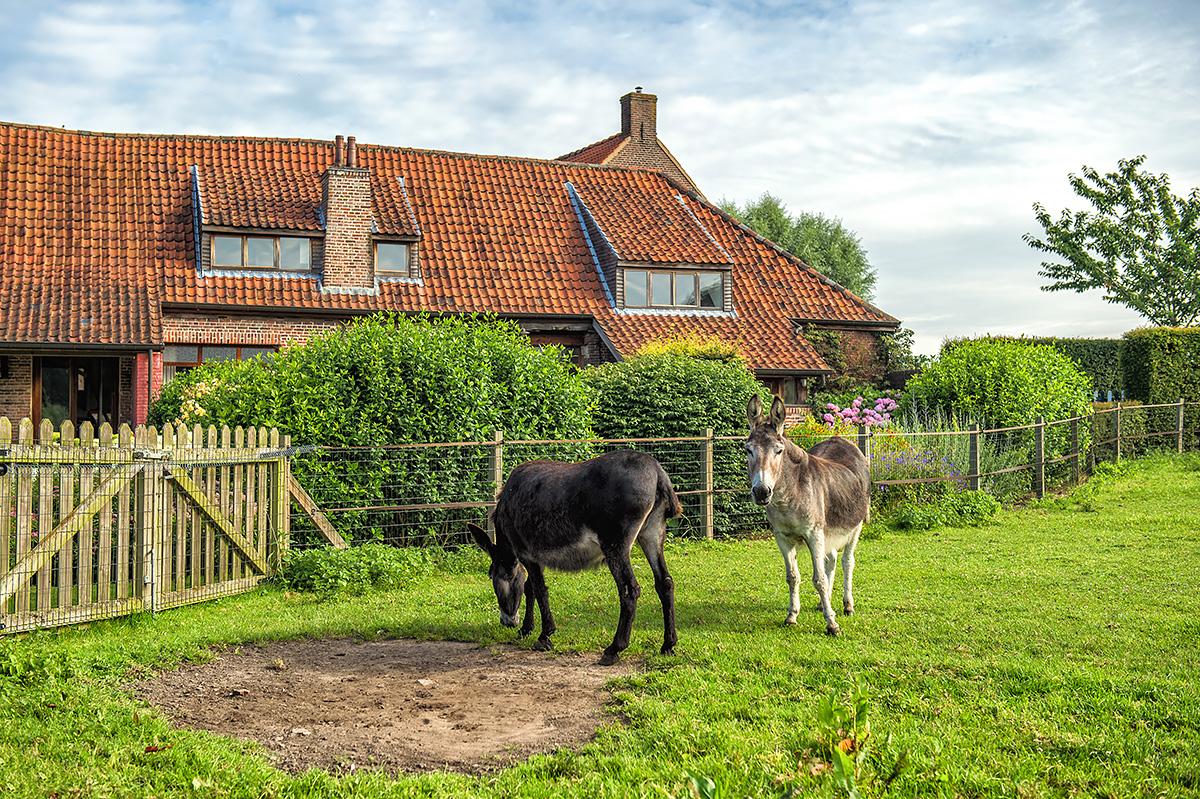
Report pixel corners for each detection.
[1121,328,1200,444]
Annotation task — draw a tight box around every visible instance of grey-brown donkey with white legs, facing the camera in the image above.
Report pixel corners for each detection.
[745,394,871,636]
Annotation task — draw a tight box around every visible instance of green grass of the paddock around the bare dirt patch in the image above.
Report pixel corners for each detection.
[0,457,1200,798]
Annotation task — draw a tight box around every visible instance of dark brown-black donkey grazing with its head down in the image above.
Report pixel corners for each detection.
[467,450,683,666]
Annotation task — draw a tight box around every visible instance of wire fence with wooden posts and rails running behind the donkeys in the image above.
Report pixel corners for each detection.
[285,401,1189,546]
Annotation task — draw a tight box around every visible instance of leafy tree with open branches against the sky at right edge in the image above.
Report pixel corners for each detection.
[1024,155,1200,328]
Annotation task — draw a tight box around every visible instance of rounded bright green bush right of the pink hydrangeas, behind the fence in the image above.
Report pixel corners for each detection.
[902,338,1092,475]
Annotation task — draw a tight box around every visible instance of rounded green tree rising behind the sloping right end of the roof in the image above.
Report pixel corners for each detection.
[719,193,876,301]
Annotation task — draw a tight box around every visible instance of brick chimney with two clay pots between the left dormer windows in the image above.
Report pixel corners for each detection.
[320,136,376,294]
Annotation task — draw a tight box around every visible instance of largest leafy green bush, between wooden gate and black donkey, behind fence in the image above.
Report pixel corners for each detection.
[150,314,592,543]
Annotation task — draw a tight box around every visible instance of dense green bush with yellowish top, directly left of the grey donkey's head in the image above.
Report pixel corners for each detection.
[583,336,770,530]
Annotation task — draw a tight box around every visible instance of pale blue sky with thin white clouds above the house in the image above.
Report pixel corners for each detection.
[0,0,1200,354]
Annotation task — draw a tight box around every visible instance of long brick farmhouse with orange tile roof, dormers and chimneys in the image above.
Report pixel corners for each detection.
[0,90,899,425]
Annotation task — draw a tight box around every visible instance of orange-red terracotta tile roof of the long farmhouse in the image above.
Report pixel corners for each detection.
[0,122,896,371]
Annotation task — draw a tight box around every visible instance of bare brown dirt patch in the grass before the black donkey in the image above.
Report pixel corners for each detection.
[130,638,632,774]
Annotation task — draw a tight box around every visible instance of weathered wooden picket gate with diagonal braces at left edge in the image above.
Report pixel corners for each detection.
[0,417,289,633]
